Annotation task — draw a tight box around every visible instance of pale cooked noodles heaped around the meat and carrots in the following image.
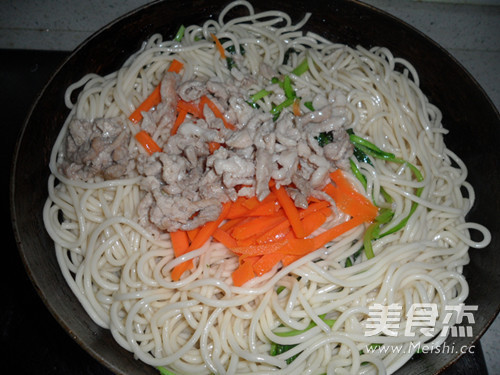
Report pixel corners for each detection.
[44,2,490,374]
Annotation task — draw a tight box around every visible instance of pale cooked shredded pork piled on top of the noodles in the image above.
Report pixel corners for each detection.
[60,66,353,231]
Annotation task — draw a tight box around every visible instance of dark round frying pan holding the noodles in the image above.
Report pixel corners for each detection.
[10,0,500,375]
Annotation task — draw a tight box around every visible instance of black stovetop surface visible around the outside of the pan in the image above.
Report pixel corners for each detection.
[0,50,487,375]
